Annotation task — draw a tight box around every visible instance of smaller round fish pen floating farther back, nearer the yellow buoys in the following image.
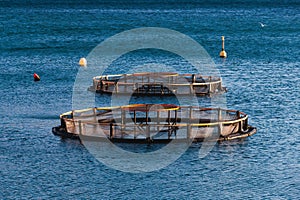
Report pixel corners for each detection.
[89,72,226,95]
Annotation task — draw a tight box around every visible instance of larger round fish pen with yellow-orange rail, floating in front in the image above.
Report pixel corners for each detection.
[52,104,256,143]
